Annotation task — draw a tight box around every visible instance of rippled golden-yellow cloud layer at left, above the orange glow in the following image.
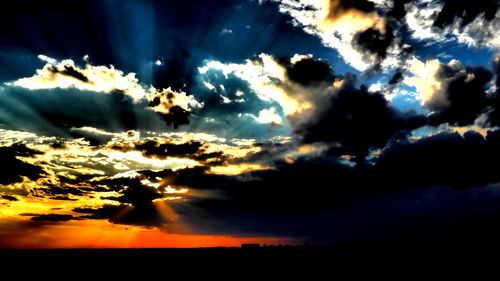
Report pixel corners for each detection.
[4,127,209,176]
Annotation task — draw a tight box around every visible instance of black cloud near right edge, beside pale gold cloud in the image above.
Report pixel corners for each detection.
[426,65,492,126]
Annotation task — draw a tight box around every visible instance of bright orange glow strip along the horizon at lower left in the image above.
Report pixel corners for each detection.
[0,220,295,249]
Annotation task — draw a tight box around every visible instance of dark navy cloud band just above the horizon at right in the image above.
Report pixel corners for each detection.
[170,185,500,244]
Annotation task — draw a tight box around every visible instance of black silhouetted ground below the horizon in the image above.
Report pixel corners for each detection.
[0,241,500,280]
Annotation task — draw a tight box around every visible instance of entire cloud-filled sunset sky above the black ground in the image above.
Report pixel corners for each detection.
[0,0,500,249]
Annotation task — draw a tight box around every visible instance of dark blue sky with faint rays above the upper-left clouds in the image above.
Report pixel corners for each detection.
[0,0,349,88]
